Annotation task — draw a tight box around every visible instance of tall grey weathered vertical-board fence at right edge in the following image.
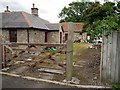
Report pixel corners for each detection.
[100,32,120,83]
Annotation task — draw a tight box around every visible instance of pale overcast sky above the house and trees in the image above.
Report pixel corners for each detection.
[0,0,118,23]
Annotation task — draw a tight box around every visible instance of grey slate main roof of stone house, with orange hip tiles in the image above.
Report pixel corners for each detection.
[0,12,50,30]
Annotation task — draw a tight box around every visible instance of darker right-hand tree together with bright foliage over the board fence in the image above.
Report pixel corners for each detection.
[84,2,120,38]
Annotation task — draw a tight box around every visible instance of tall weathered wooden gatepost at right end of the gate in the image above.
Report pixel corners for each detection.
[66,22,73,81]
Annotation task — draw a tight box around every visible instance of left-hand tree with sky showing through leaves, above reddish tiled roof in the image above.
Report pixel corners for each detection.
[59,2,92,22]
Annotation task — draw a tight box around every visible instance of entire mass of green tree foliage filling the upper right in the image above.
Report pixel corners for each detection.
[59,1,120,39]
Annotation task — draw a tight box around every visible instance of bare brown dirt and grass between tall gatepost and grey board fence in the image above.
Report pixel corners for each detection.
[73,44,100,85]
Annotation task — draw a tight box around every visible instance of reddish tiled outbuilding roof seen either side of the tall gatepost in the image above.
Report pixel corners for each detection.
[61,22,84,33]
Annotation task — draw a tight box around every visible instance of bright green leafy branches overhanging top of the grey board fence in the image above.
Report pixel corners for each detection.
[86,16,119,38]
